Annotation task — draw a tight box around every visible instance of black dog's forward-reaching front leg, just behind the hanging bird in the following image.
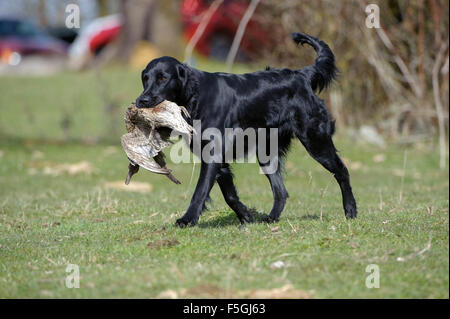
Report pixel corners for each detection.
[175,162,220,227]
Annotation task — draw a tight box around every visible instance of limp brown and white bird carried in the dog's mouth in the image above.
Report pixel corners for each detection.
[121,101,194,185]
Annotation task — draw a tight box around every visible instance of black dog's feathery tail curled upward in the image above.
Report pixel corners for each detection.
[292,32,338,92]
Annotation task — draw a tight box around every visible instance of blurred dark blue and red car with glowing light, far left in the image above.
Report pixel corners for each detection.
[0,18,67,65]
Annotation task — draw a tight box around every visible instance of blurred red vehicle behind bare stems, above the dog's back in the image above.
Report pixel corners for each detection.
[181,0,269,60]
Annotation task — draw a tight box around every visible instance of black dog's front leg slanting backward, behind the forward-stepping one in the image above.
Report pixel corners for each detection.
[217,164,254,224]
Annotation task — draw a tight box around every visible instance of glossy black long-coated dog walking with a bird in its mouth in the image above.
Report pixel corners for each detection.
[136,33,357,227]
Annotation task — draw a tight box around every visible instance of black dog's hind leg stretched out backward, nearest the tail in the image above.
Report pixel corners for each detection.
[297,128,357,218]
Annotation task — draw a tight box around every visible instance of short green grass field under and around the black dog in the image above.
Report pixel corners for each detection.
[0,60,449,298]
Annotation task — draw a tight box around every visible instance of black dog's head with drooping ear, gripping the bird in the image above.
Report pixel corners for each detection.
[136,57,187,108]
